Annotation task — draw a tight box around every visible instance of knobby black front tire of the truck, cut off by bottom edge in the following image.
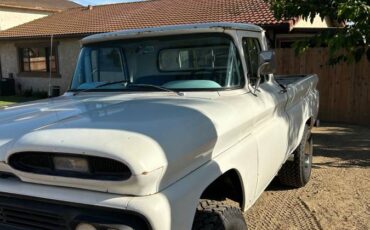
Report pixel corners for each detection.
[193,200,247,230]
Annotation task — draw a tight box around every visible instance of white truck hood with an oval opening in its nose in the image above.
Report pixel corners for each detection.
[0,93,246,195]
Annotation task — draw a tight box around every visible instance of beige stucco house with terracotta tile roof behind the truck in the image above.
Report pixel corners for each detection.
[0,0,333,93]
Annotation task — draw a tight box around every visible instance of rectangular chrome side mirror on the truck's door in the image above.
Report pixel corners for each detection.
[254,51,276,93]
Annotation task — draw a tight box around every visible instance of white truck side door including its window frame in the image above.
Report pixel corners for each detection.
[238,31,289,195]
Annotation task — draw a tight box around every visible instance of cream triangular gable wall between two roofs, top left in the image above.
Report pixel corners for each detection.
[0,7,51,30]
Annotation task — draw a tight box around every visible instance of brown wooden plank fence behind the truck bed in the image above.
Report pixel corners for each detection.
[275,48,370,125]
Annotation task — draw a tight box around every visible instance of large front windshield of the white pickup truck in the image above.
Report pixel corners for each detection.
[71,34,244,91]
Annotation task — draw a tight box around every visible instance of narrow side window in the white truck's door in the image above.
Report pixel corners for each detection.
[243,38,265,85]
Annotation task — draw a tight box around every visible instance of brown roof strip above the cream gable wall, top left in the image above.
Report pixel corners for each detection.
[0,0,81,11]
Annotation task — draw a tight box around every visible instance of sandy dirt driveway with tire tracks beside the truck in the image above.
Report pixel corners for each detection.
[245,124,370,229]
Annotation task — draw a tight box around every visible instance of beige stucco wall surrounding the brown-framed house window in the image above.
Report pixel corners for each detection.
[0,39,80,93]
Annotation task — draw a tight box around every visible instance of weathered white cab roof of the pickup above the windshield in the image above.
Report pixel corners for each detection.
[82,22,263,45]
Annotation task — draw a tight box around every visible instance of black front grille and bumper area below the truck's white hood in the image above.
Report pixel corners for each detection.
[0,194,151,230]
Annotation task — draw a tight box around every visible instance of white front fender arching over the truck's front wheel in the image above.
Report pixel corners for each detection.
[128,135,258,230]
